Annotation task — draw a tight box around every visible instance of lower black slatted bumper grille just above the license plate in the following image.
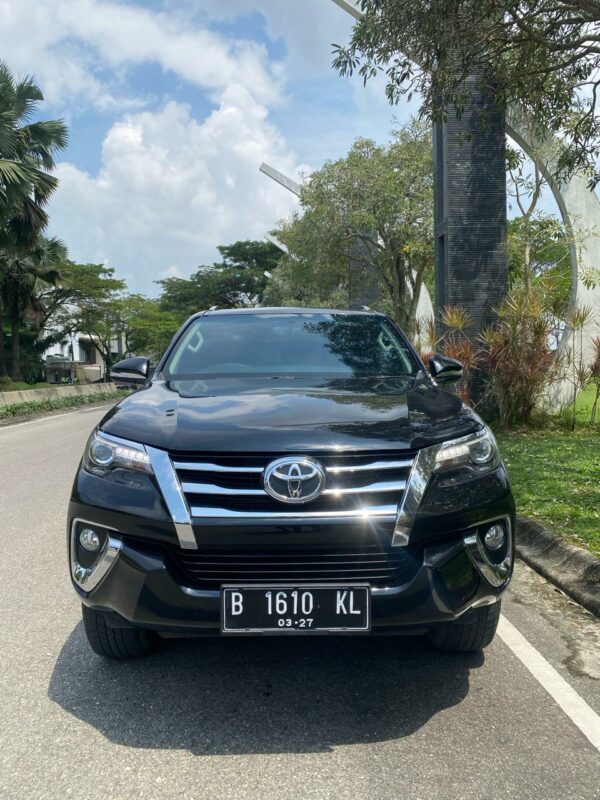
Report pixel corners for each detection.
[168,545,422,588]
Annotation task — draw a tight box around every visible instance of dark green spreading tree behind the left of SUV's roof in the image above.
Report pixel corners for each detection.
[157,241,281,322]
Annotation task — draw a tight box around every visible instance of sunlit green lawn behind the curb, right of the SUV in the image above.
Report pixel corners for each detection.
[496,427,600,556]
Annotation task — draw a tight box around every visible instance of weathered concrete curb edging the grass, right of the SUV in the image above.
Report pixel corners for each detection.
[516,516,600,617]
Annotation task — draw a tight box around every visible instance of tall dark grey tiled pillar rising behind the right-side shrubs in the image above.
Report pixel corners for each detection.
[433,78,508,337]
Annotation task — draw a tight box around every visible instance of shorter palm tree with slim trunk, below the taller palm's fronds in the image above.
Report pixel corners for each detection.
[6,236,67,381]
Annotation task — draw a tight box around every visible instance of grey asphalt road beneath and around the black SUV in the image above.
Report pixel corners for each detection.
[0,410,600,800]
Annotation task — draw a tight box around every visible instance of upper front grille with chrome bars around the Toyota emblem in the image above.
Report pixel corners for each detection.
[171,453,413,520]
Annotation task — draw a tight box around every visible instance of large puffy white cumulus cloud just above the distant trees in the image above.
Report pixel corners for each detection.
[51,86,307,291]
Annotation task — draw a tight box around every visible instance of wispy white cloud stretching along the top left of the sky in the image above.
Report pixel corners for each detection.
[0,0,281,109]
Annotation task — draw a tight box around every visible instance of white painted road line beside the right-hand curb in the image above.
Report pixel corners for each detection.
[498,614,600,752]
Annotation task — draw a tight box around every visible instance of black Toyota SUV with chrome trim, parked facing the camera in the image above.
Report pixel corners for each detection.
[68,308,515,658]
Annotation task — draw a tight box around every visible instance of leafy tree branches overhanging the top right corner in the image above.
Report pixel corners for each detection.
[334,0,600,185]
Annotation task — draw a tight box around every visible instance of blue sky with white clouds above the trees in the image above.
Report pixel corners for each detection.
[0,0,409,294]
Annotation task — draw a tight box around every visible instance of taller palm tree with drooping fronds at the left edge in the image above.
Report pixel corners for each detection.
[0,62,68,377]
